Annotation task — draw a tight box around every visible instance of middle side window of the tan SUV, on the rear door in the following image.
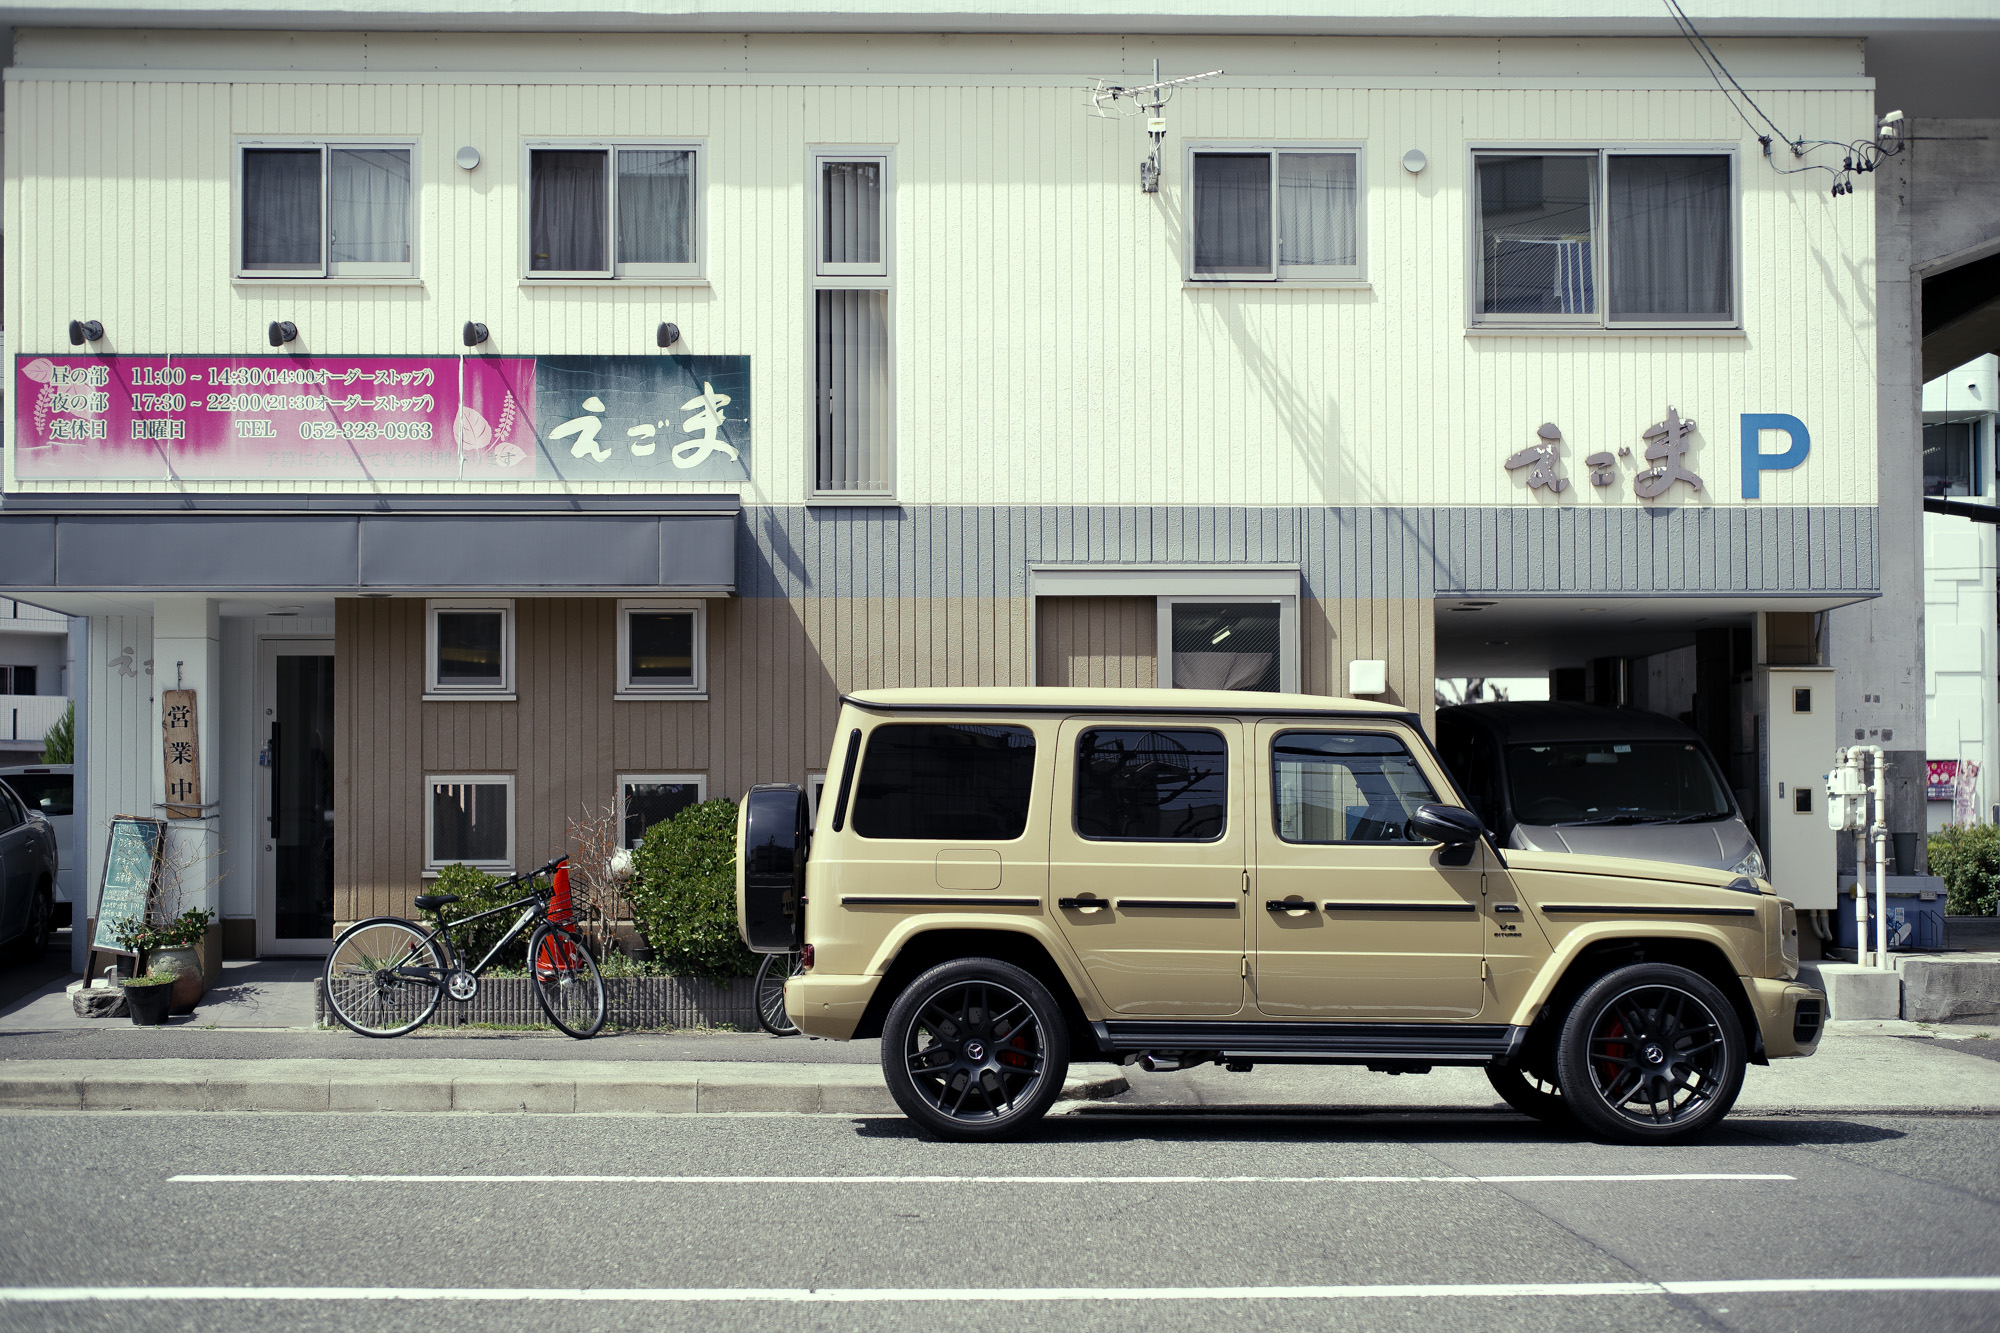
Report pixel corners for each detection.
[1076,727,1230,843]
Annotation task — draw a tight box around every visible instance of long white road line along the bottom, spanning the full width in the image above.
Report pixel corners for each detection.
[0,1277,2000,1305]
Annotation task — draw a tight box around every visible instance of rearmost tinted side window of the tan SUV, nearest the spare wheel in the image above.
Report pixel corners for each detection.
[854,723,1034,843]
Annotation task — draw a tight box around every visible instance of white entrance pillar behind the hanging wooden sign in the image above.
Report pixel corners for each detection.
[150,596,222,981]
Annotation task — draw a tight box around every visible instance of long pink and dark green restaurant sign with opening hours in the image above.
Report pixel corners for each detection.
[12,354,750,484]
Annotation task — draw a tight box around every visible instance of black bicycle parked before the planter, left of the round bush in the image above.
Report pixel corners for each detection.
[326,857,604,1041]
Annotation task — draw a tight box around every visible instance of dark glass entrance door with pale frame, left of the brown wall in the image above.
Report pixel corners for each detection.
[254,638,334,955]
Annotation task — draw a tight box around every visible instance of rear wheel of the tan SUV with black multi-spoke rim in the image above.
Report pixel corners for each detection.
[882,959,1070,1141]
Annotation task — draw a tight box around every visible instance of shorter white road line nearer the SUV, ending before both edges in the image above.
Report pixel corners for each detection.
[166,1171,1798,1185]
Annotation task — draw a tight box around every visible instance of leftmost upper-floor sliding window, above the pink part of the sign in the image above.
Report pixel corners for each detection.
[236,140,416,278]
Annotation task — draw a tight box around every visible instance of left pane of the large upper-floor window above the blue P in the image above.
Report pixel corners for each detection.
[1476,152,1598,318]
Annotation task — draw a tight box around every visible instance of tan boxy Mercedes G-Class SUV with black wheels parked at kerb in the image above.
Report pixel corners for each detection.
[736,689,1826,1143]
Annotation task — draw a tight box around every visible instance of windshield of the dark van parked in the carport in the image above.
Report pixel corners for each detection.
[1506,741,1730,825]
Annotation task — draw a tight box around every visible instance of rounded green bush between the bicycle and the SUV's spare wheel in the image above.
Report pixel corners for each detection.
[628,799,756,981]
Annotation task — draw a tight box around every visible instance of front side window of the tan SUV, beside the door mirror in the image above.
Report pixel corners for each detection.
[1270,731,1438,843]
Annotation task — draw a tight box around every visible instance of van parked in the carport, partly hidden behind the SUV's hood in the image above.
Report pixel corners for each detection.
[1438,703,1764,879]
